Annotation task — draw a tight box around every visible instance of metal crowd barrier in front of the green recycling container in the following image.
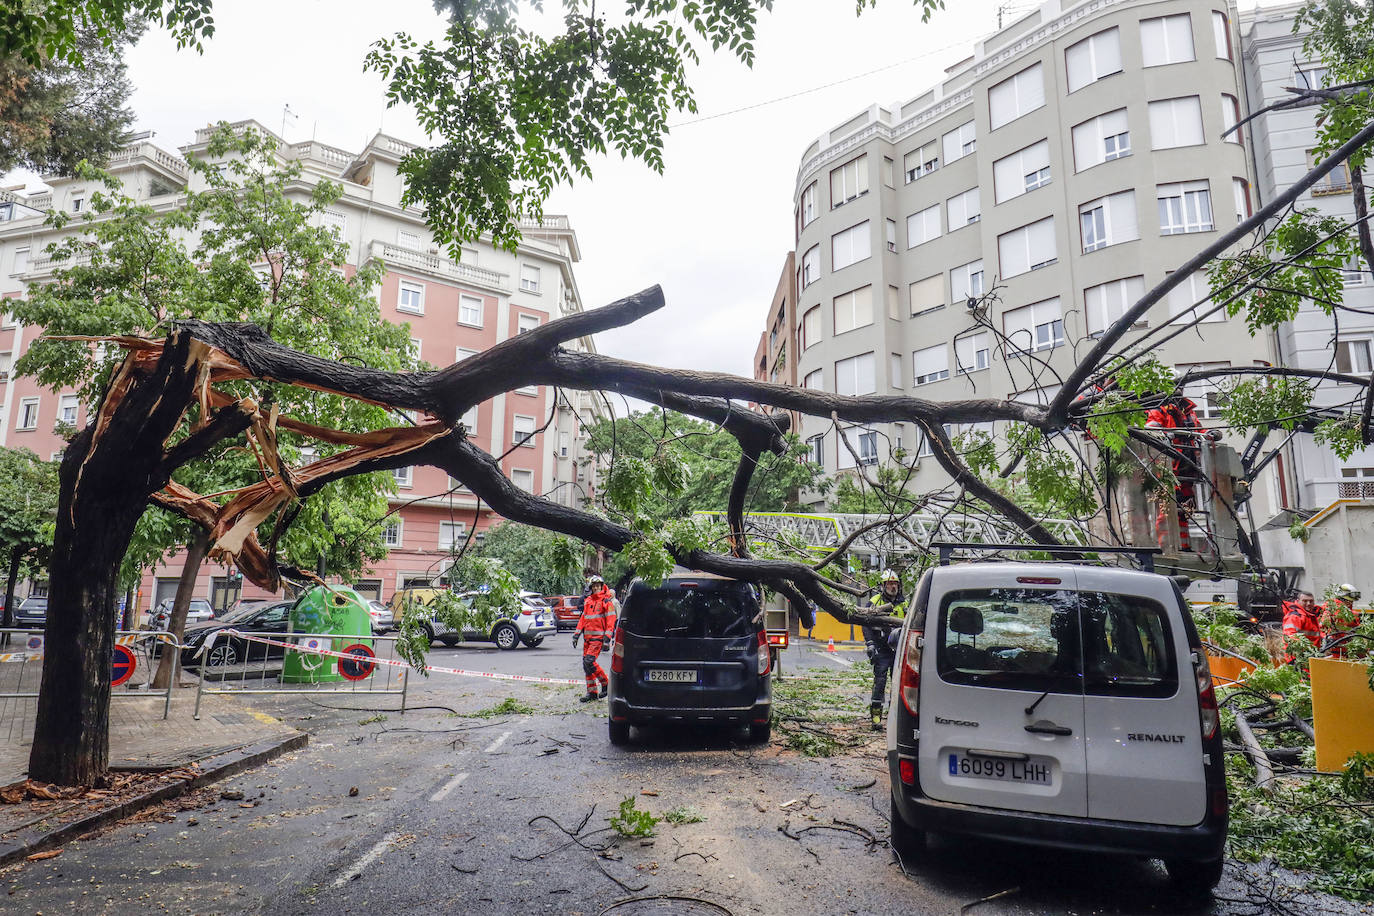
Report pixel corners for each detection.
[192,630,409,718]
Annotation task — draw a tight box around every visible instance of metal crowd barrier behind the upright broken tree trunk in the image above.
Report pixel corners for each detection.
[0,628,180,718]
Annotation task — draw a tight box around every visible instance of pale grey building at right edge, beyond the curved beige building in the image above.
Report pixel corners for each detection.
[1241,4,1374,509]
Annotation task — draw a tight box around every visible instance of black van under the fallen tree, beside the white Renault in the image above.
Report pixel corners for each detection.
[610,573,772,744]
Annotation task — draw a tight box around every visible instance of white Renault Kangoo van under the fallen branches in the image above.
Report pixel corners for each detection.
[888,562,1227,891]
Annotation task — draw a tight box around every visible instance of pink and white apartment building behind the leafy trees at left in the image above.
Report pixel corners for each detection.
[0,121,596,607]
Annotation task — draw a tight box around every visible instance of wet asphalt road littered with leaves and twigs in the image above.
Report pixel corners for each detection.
[0,634,1358,916]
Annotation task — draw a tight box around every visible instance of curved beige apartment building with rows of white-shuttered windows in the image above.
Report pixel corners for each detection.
[793,0,1276,519]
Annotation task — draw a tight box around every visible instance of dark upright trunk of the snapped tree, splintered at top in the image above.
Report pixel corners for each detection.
[29,334,206,786]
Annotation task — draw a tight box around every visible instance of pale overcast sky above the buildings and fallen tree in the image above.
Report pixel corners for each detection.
[107,0,1249,375]
